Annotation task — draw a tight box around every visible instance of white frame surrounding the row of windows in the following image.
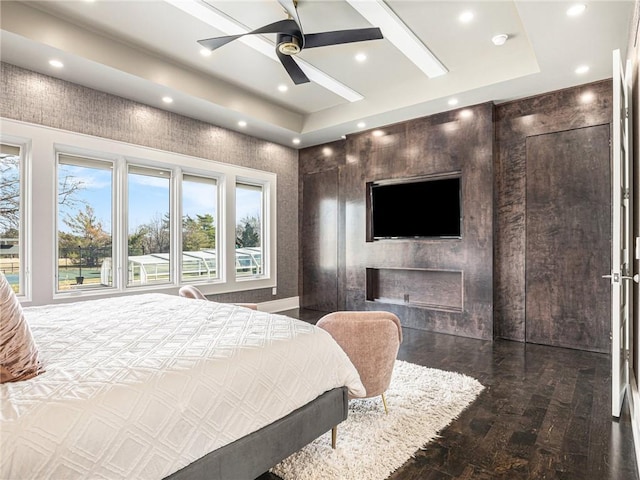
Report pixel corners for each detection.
[0,119,277,305]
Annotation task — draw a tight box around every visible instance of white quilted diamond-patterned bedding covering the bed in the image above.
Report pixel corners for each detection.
[0,294,364,479]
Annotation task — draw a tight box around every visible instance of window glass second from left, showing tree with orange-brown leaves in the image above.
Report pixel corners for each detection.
[56,154,114,292]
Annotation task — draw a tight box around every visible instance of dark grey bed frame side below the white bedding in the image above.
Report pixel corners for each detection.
[166,387,349,480]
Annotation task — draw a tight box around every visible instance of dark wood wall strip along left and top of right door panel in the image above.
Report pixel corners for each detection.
[494,80,612,341]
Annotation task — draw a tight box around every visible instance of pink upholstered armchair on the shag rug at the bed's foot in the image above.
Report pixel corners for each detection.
[317,311,402,412]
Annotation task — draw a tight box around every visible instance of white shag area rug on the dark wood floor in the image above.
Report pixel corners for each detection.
[271,360,484,480]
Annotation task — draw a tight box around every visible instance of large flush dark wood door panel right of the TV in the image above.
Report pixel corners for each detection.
[525,125,611,352]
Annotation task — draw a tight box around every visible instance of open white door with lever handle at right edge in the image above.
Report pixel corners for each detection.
[607,50,634,417]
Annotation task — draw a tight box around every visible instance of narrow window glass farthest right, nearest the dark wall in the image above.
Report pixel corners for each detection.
[236,183,264,278]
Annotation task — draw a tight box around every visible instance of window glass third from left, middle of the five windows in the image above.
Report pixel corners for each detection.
[127,165,173,286]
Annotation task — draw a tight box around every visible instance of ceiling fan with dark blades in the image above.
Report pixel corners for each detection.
[198,0,383,85]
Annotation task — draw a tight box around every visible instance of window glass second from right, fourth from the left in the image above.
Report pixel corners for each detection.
[181,174,219,282]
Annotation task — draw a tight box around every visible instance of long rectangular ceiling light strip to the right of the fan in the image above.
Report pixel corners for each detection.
[347,0,447,78]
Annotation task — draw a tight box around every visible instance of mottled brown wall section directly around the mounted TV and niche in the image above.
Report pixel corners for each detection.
[300,104,494,339]
